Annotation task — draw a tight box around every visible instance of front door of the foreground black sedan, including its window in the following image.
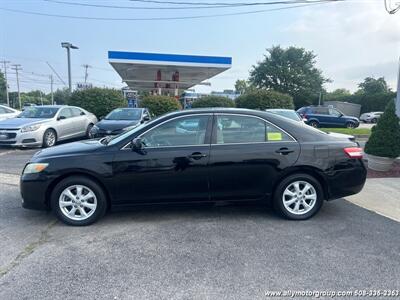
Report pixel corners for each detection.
[113,114,212,204]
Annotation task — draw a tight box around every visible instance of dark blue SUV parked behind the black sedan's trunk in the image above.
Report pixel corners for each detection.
[297,106,360,128]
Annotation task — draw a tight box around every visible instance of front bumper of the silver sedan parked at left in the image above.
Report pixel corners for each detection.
[0,128,44,147]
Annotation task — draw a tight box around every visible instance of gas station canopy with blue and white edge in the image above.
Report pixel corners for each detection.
[108,51,232,96]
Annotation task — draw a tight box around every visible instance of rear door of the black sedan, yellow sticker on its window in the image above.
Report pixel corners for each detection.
[209,114,300,201]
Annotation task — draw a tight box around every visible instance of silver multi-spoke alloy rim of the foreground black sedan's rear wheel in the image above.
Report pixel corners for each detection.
[282,181,317,215]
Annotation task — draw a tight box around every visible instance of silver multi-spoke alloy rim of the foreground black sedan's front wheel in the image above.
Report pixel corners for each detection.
[58,185,97,221]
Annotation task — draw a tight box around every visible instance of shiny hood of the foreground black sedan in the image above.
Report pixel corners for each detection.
[33,140,104,159]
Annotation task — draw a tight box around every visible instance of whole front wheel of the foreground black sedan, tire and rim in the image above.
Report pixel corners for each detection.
[51,176,107,226]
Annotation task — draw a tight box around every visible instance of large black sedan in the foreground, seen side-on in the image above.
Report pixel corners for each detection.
[21,108,366,225]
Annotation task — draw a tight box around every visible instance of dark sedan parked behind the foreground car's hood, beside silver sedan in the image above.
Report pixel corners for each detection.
[90,108,150,138]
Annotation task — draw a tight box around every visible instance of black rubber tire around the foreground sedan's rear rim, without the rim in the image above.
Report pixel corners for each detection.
[272,173,324,220]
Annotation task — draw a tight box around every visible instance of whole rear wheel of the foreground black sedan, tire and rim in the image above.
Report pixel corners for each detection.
[272,173,323,220]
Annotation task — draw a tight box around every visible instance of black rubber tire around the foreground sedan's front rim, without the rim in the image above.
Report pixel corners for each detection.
[51,176,107,226]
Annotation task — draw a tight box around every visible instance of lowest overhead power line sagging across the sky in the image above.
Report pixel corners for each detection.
[0,0,345,21]
